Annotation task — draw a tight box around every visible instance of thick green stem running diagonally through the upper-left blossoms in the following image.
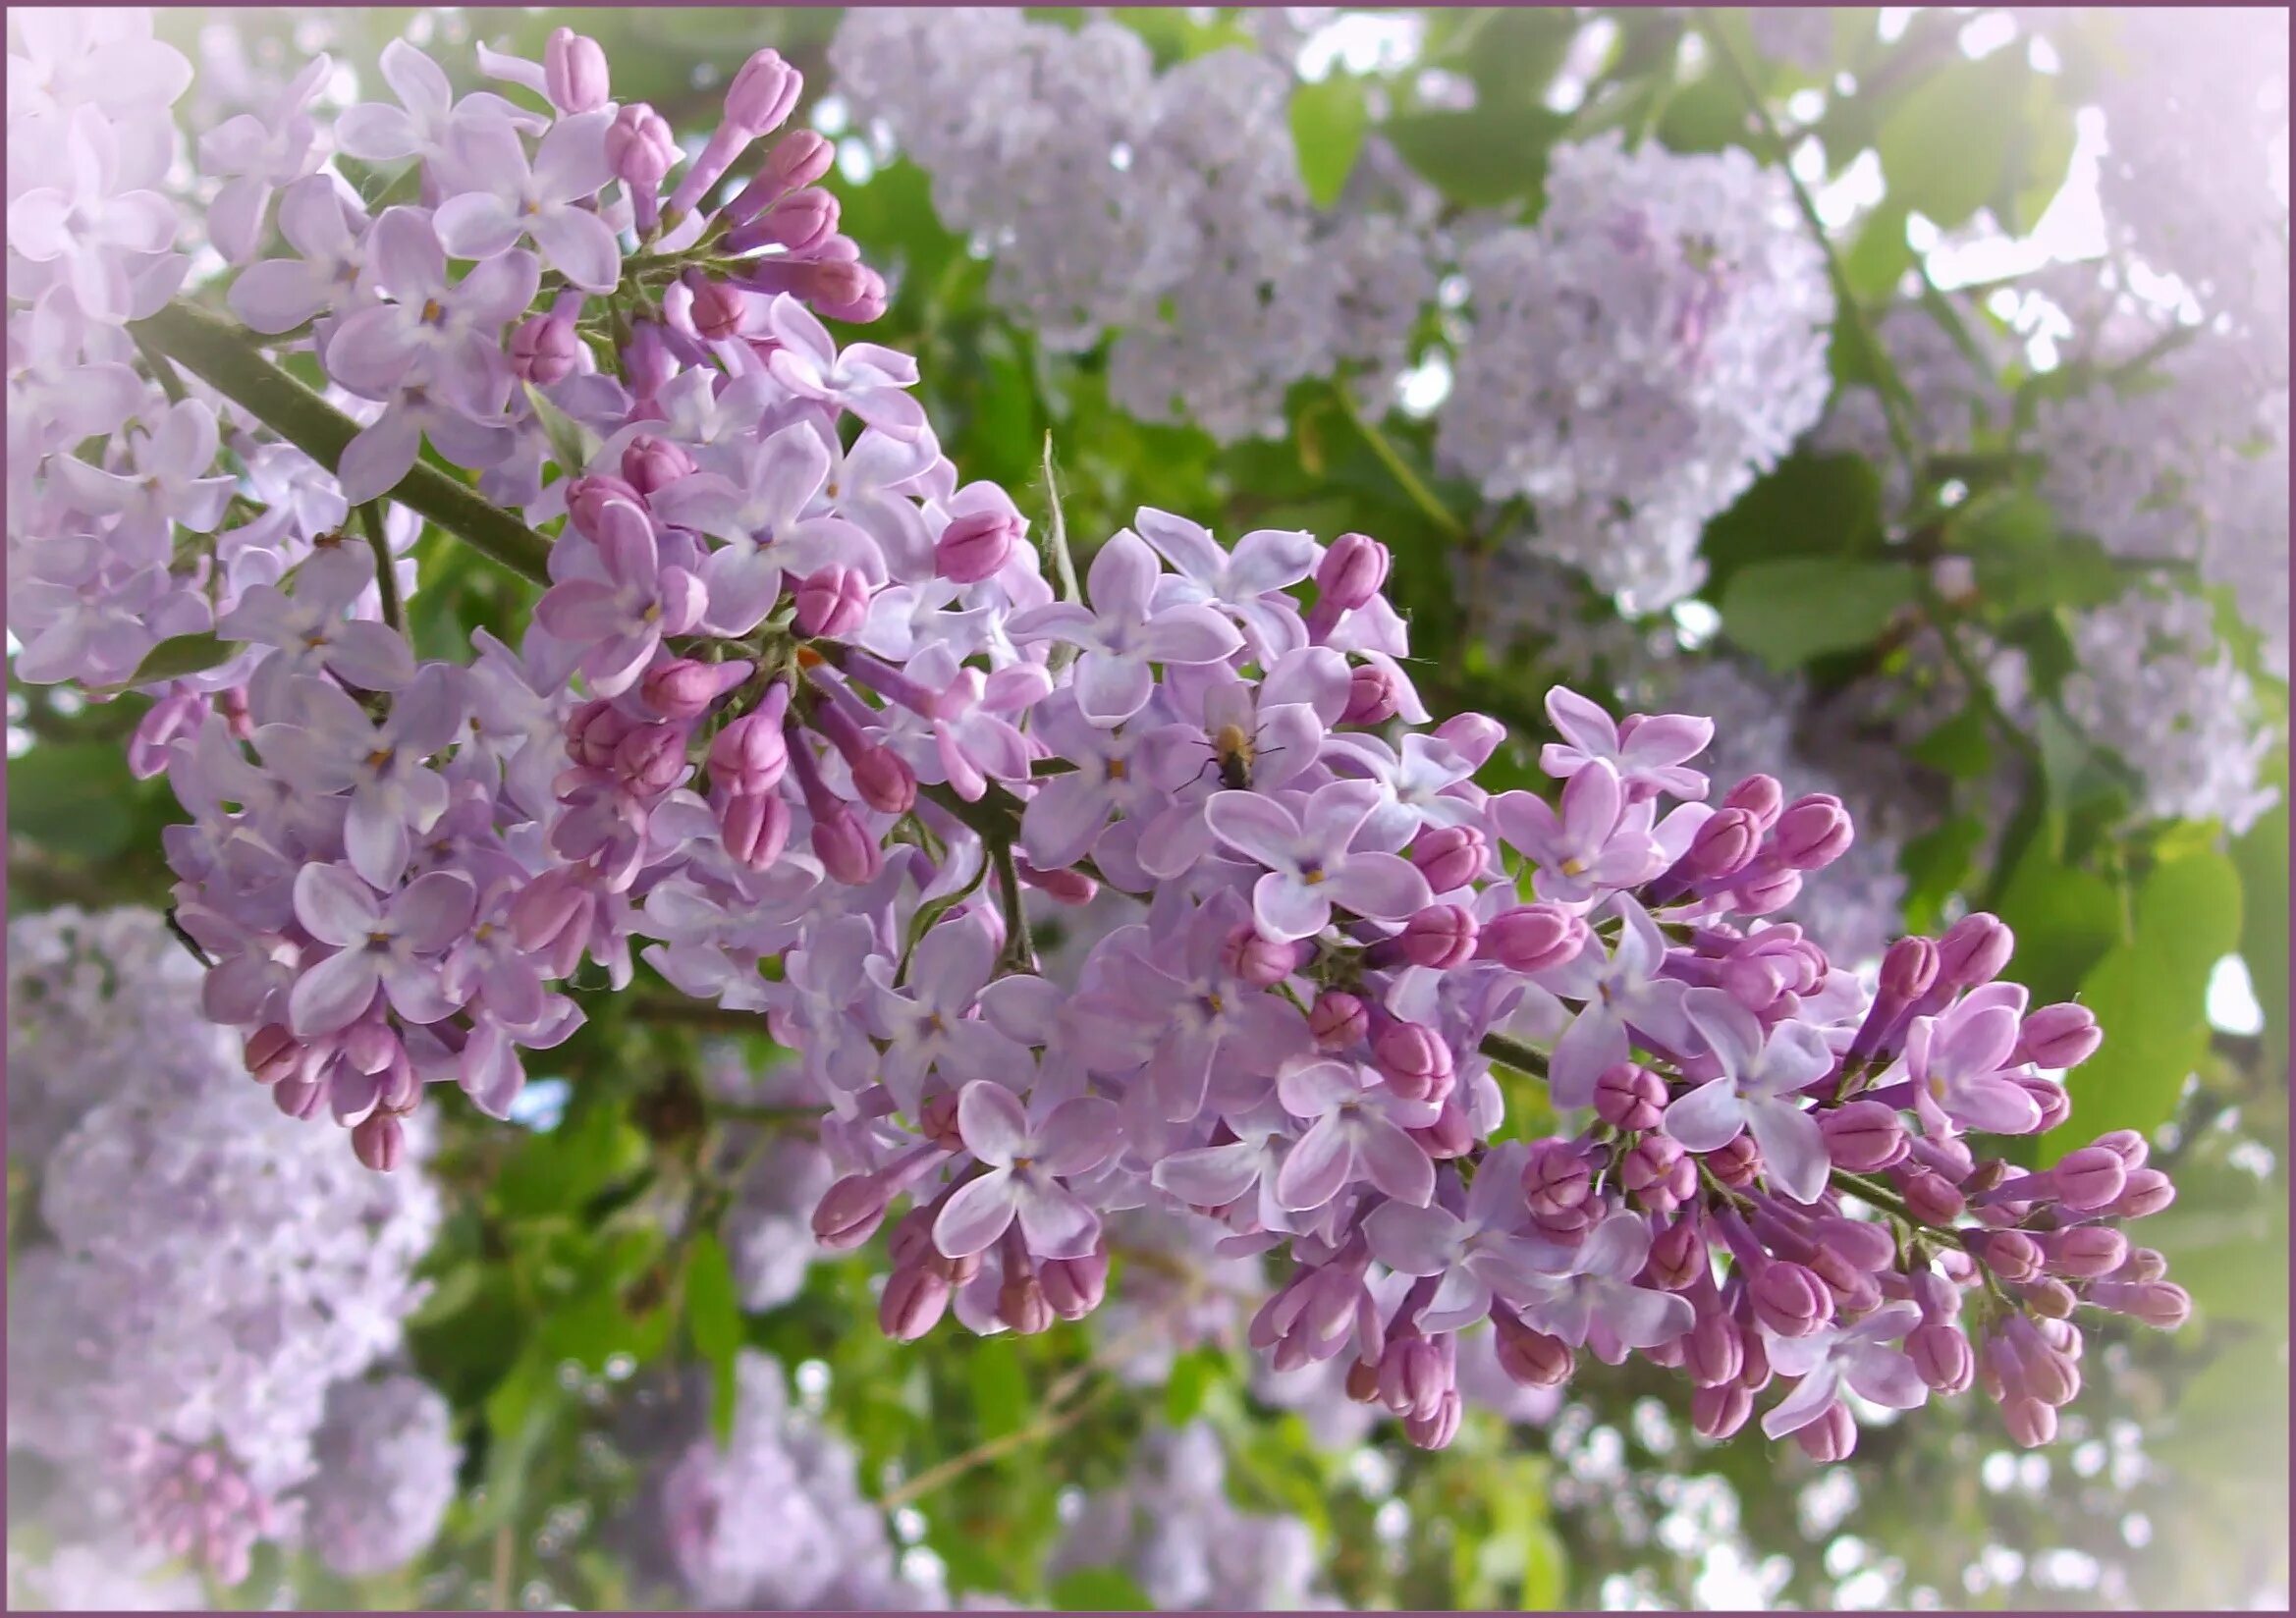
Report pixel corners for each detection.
[129,300,551,583]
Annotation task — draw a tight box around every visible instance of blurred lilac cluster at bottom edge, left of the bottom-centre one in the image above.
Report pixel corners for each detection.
[618,1350,949,1611]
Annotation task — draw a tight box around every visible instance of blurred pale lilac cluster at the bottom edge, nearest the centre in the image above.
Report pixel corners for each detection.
[1045,1423,1345,1613]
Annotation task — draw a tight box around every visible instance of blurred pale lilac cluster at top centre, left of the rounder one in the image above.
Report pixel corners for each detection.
[829,9,1440,438]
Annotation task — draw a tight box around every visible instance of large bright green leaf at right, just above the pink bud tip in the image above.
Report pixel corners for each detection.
[2041,849,2241,1165]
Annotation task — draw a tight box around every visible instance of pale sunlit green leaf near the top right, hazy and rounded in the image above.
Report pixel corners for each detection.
[1876,50,2032,230]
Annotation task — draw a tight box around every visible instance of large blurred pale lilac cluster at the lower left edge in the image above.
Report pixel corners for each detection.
[9,911,439,1584]
